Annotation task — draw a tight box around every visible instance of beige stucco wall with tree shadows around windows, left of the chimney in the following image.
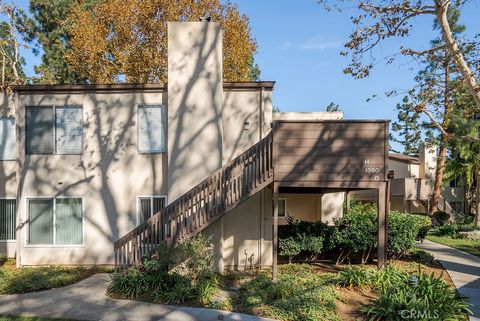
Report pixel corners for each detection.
[17,91,167,265]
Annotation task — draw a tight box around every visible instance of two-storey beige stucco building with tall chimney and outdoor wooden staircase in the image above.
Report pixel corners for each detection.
[0,22,388,270]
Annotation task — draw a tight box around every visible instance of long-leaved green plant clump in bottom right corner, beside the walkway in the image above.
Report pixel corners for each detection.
[337,266,470,321]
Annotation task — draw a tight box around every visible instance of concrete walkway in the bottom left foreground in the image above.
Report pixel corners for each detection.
[0,274,271,321]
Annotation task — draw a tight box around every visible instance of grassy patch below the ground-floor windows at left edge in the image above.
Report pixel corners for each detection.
[0,260,109,292]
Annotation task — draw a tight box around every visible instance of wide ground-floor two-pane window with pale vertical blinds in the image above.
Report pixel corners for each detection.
[27,197,83,245]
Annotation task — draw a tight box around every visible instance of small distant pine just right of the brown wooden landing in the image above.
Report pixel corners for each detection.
[390,96,422,156]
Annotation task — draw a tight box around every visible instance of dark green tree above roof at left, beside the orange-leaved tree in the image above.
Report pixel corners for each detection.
[29,0,88,84]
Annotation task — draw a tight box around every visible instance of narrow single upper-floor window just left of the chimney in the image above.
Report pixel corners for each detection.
[137,105,167,153]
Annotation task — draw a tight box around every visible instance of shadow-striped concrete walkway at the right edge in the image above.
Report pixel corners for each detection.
[417,240,480,321]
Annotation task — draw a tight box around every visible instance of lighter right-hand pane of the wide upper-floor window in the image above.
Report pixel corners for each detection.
[55,106,83,154]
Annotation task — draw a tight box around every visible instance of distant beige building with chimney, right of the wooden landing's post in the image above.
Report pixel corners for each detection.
[349,144,465,213]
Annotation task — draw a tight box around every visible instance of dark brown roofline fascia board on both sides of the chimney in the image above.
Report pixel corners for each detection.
[12,81,275,93]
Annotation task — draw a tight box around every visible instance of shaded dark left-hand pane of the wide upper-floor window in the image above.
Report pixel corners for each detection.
[25,107,54,154]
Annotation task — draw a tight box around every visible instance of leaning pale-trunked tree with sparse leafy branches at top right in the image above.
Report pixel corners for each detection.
[318,0,480,109]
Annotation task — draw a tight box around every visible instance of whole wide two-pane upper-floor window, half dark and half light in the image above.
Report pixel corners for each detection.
[25,106,83,154]
